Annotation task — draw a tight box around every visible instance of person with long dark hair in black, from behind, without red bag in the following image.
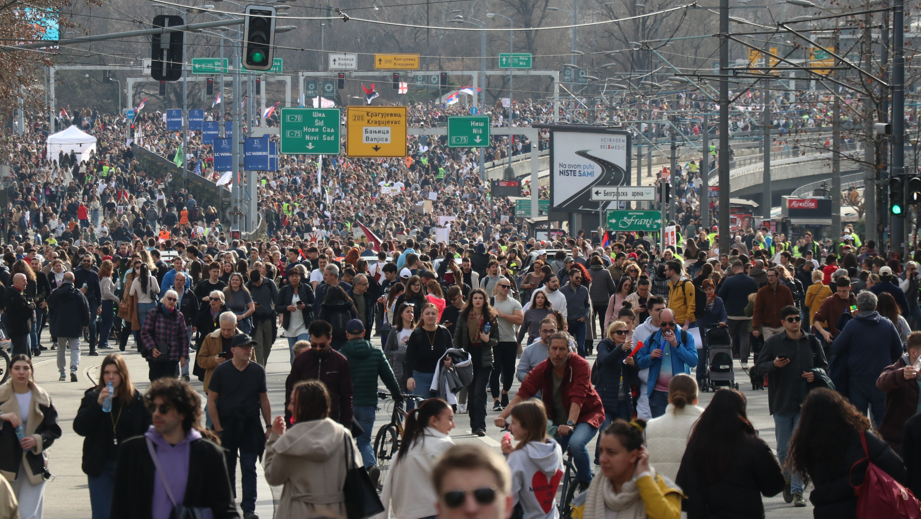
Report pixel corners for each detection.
[675,389,784,519]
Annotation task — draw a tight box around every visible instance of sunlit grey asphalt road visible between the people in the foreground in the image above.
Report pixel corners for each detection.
[34,331,812,519]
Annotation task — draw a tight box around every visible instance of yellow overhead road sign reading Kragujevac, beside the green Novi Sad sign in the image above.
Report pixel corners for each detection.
[345,106,407,158]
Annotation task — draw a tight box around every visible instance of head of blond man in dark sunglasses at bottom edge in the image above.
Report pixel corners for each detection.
[432,443,514,519]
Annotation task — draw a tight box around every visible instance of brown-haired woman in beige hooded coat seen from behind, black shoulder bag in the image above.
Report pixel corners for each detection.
[264,380,363,519]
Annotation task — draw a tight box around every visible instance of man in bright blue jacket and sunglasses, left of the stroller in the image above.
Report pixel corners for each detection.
[636,308,697,418]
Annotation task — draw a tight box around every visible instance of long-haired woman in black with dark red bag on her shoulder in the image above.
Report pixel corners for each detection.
[787,388,908,519]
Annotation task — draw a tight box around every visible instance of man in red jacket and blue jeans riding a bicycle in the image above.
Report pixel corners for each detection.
[495,332,604,492]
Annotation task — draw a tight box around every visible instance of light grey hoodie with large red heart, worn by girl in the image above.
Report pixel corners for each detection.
[508,439,563,519]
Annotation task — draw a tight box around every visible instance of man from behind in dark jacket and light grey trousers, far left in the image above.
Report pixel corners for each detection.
[48,272,90,382]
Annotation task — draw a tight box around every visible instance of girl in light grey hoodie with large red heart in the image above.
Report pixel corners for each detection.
[501,400,563,519]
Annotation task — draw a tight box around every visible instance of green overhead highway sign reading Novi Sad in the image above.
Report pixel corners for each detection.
[278,108,341,155]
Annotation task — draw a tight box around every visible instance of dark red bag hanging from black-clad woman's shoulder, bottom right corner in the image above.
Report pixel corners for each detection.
[848,431,921,519]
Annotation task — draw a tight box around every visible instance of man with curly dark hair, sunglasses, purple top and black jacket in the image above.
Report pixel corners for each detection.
[109,378,240,519]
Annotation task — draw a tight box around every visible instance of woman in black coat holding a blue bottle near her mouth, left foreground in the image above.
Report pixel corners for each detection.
[74,353,150,517]
